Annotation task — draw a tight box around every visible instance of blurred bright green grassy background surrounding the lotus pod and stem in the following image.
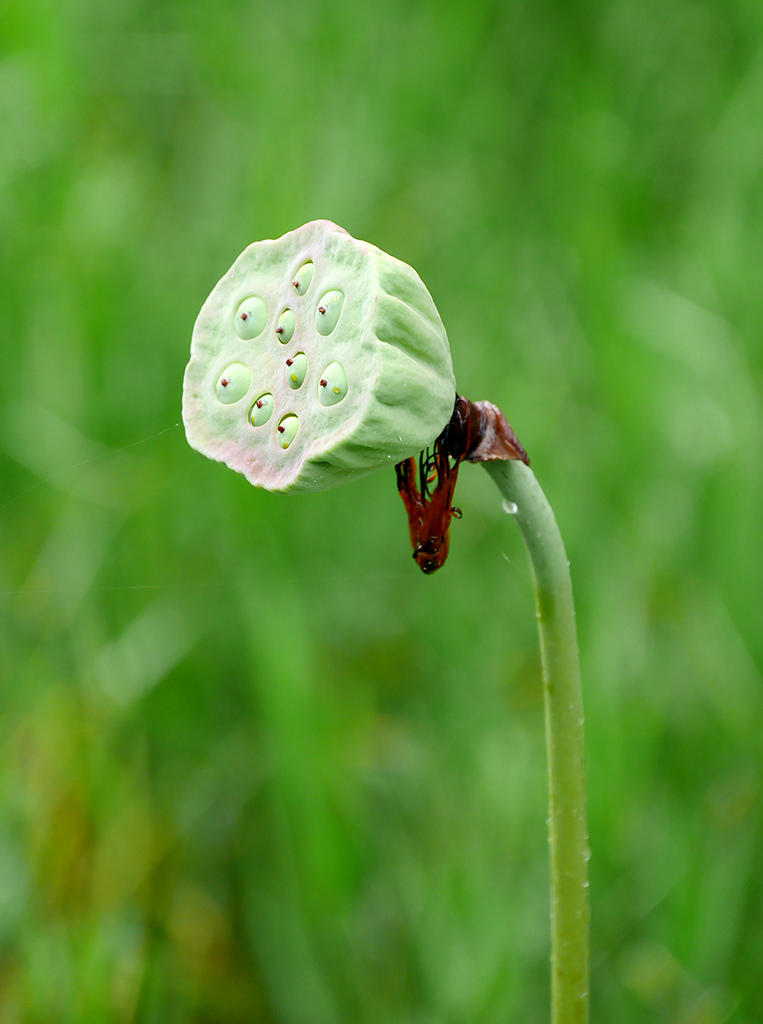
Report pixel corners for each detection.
[0,0,763,1024]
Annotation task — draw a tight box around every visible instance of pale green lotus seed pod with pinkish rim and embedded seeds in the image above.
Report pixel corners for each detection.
[183,220,456,490]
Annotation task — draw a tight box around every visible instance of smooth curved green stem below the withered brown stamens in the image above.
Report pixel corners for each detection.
[483,461,590,1024]
